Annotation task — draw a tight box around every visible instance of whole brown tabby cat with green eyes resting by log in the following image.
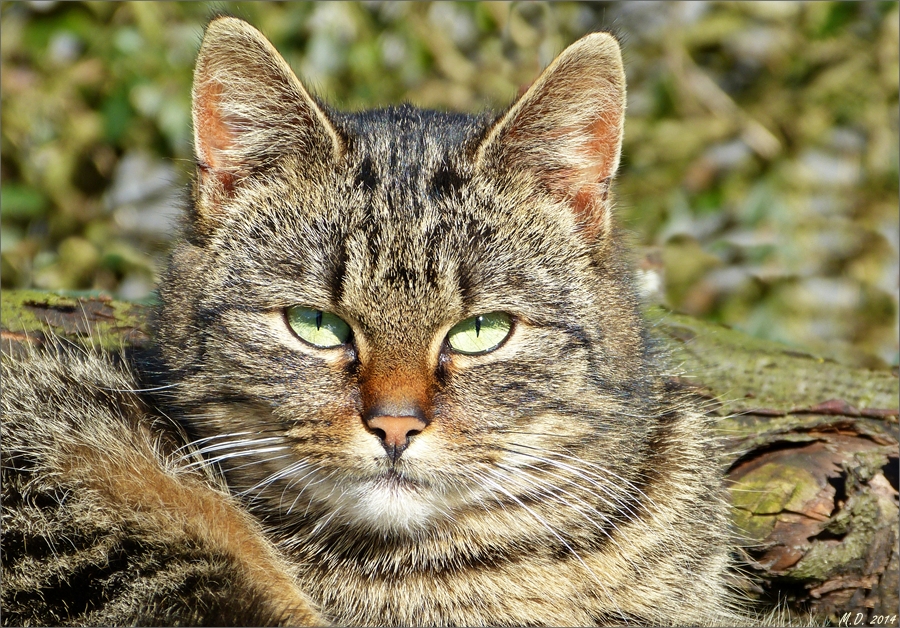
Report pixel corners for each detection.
[2,17,745,626]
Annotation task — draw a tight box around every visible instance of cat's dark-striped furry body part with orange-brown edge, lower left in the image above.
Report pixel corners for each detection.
[2,353,325,626]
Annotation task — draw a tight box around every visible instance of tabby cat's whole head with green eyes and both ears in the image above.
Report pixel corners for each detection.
[159,18,653,534]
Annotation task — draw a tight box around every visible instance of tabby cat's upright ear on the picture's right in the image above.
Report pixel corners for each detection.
[476,33,625,241]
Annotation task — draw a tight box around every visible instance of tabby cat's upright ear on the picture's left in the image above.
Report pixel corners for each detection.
[192,17,342,213]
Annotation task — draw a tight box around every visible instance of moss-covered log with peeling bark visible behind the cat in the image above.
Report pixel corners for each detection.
[0,291,900,625]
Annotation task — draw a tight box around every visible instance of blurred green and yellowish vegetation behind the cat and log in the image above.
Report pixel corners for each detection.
[0,2,900,366]
